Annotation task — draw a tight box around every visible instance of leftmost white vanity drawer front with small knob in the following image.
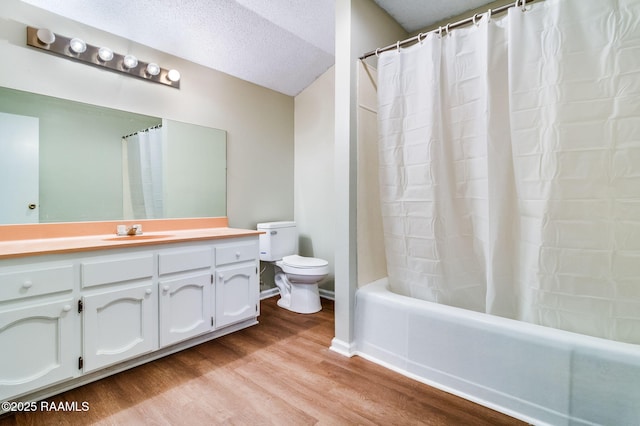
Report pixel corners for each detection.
[0,265,73,302]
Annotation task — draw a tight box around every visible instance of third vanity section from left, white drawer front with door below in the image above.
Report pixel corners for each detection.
[158,247,213,347]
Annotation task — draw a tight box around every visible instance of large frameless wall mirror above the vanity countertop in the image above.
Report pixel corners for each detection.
[0,88,227,225]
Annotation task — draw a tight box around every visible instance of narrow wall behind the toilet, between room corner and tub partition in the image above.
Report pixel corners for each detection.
[294,67,335,291]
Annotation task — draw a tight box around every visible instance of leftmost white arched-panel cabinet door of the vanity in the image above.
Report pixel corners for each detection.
[0,299,75,401]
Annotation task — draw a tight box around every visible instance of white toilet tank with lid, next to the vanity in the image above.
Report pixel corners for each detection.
[257,222,298,262]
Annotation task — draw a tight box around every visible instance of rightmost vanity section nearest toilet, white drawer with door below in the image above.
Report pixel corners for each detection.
[215,241,260,328]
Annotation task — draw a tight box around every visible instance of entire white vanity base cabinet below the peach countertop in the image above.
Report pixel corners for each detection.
[0,235,259,406]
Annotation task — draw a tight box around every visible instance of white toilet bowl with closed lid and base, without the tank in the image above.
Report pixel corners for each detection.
[274,255,329,314]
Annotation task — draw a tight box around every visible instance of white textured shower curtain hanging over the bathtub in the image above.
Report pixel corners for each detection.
[378,0,640,343]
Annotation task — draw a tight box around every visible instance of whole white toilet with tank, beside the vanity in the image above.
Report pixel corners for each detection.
[257,222,329,314]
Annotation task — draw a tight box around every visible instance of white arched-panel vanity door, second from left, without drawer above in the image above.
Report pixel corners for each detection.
[82,279,158,373]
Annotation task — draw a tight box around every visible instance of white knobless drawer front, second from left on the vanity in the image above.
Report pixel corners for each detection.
[82,253,153,287]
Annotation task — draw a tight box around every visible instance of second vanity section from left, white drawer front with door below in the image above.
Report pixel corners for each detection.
[78,252,158,373]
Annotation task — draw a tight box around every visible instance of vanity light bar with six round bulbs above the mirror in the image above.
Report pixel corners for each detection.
[27,27,180,89]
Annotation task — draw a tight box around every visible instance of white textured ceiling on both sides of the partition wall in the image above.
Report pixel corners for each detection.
[22,0,487,96]
